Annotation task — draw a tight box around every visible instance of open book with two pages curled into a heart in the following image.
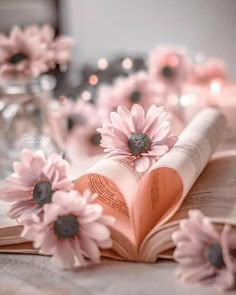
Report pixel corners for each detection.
[0,108,236,262]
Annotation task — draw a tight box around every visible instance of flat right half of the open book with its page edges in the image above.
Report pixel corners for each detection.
[142,151,236,261]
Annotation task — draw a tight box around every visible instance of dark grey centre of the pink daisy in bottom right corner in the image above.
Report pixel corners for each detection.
[204,243,225,269]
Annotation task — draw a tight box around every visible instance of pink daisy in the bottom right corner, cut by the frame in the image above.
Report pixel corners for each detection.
[173,210,236,289]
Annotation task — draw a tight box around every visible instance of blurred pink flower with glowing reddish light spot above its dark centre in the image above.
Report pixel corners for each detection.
[148,47,192,95]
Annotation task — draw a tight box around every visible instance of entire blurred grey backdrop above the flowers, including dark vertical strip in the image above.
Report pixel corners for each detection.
[0,0,236,92]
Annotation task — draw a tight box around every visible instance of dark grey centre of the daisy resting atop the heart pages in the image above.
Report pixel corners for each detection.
[128,133,151,156]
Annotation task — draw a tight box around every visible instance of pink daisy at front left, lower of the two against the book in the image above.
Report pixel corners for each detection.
[22,191,114,268]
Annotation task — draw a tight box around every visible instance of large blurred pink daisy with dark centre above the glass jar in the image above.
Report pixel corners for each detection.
[0,27,52,79]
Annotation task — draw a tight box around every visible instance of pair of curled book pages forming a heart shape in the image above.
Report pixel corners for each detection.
[75,108,225,258]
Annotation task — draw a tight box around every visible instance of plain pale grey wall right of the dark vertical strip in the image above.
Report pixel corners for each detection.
[61,0,236,76]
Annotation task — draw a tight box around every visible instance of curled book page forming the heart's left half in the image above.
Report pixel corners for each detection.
[75,159,142,250]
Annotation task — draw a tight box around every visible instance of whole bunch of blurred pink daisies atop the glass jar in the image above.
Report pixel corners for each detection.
[0,26,72,79]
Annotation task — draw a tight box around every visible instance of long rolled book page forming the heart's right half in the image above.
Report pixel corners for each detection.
[135,108,225,243]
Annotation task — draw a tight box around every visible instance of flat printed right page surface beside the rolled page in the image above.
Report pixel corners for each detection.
[168,151,236,225]
